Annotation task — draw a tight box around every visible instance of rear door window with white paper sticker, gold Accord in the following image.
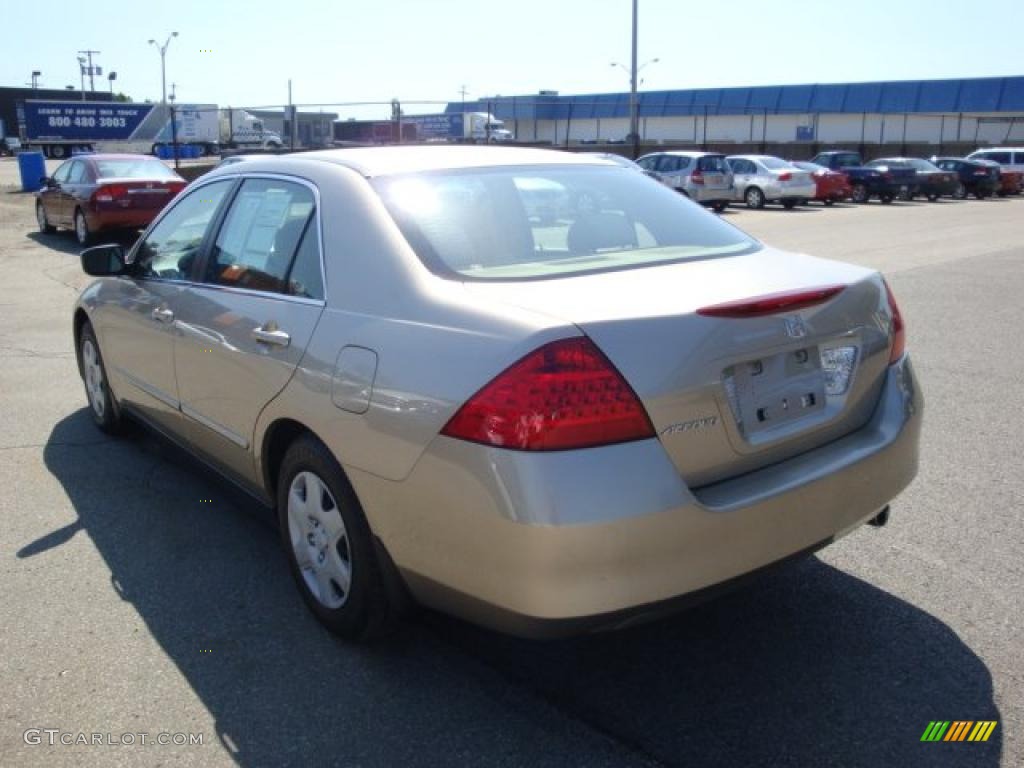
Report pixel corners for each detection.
[205,178,318,293]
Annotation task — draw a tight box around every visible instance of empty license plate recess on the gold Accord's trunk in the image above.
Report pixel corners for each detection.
[725,345,825,437]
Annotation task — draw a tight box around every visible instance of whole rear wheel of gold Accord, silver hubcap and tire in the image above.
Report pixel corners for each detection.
[278,435,395,640]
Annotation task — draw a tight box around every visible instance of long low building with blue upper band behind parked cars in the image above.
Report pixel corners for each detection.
[447,77,1024,145]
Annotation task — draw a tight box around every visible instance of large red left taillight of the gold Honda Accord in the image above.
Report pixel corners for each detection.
[441,337,654,451]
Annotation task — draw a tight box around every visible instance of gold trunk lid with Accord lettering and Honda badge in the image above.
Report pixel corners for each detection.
[466,249,890,487]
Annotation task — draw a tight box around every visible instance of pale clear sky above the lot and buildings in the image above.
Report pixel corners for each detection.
[0,0,1024,118]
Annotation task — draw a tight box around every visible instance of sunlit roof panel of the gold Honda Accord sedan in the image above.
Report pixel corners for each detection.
[293,145,611,177]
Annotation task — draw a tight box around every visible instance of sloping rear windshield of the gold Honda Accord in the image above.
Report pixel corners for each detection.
[373,165,760,281]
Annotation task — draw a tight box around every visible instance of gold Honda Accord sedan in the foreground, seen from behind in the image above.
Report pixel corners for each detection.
[73,146,923,638]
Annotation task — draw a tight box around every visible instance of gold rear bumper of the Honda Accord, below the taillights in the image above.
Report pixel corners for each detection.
[351,357,924,636]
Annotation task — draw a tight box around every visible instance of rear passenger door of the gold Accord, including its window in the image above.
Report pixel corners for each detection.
[174,176,324,480]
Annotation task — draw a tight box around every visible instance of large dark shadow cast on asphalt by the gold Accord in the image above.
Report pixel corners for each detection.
[32,409,1002,766]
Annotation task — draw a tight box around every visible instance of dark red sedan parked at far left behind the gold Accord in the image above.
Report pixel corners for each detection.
[36,155,187,246]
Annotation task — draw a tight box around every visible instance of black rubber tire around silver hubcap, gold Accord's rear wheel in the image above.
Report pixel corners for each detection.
[278,435,399,641]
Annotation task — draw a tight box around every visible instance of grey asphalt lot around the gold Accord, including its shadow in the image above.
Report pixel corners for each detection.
[0,169,1024,767]
